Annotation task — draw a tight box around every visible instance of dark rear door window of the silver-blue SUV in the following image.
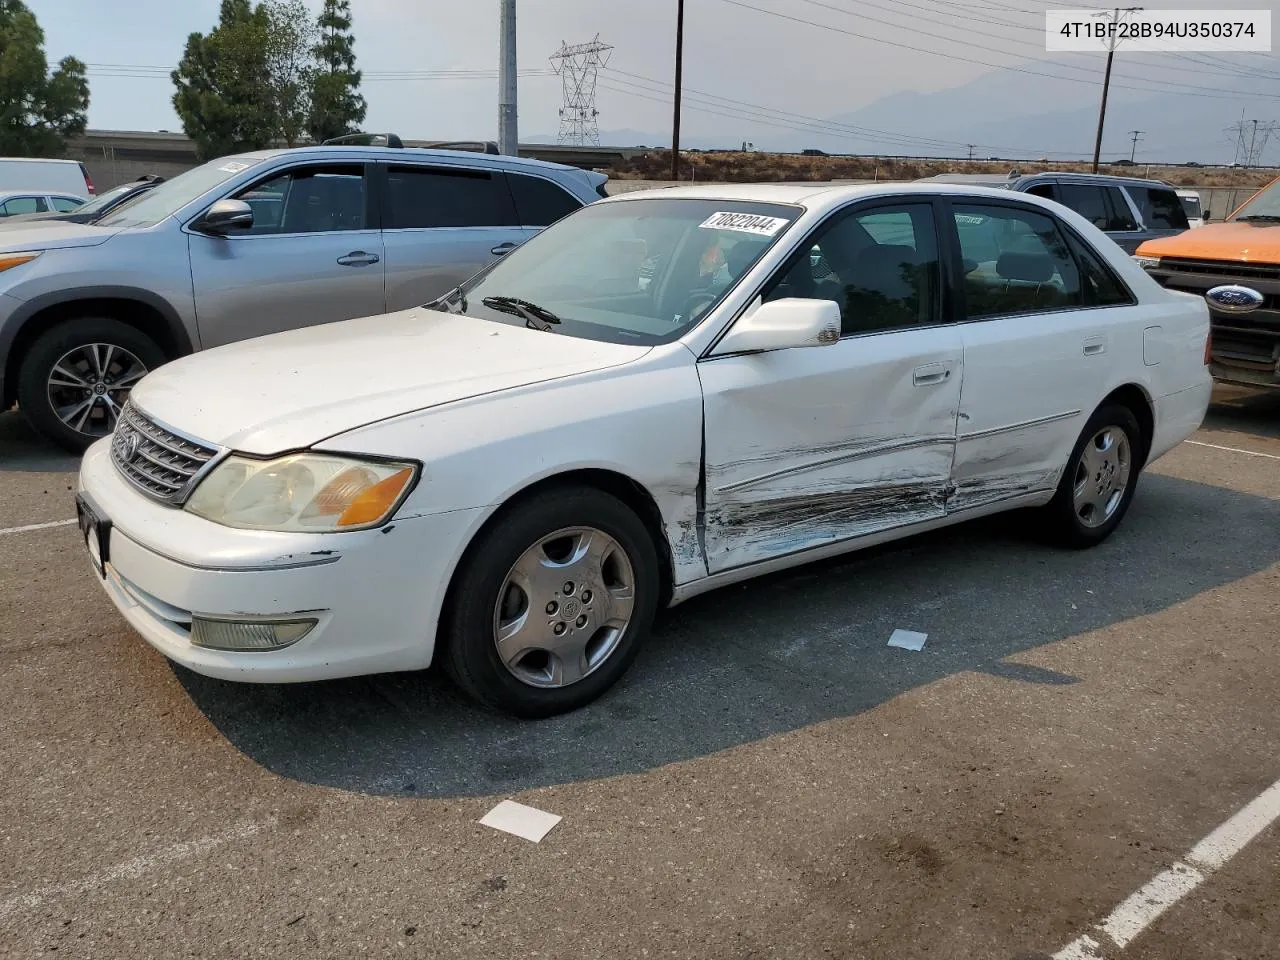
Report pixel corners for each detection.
[383,165,520,230]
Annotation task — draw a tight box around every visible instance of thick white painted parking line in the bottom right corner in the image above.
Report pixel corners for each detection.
[1053,780,1280,960]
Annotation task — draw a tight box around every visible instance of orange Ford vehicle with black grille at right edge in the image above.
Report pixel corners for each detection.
[1134,179,1280,389]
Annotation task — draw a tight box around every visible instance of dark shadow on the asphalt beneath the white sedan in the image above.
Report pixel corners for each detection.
[174,474,1280,797]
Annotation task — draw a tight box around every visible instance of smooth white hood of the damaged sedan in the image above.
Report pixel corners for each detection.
[133,307,650,453]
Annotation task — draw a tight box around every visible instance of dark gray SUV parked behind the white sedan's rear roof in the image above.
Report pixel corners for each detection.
[924,172,1190,253]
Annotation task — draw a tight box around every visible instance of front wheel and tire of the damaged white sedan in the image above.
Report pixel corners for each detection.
[440,488,660,718]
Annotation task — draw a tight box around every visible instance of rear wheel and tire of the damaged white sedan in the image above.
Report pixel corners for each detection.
[1043,403,1146,549]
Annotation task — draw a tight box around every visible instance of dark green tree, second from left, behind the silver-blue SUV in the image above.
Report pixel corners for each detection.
[172,0,280,160]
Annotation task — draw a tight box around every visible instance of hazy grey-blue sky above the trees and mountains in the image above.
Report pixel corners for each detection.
[27,0,1280,148]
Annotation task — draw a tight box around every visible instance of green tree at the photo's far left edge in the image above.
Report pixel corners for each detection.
[0,0,88,156]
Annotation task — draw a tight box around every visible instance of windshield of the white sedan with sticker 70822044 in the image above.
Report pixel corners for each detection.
[433,198,803,346]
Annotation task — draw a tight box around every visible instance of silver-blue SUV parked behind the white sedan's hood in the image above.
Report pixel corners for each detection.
[0,146,608,451]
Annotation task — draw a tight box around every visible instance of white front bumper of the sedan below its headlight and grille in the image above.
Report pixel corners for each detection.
[79,440,480,682]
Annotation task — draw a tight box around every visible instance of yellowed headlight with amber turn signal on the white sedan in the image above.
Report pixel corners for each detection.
[186,453,417,534]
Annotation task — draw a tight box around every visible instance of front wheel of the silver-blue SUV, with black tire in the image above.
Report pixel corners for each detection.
[18,316,165,453]
